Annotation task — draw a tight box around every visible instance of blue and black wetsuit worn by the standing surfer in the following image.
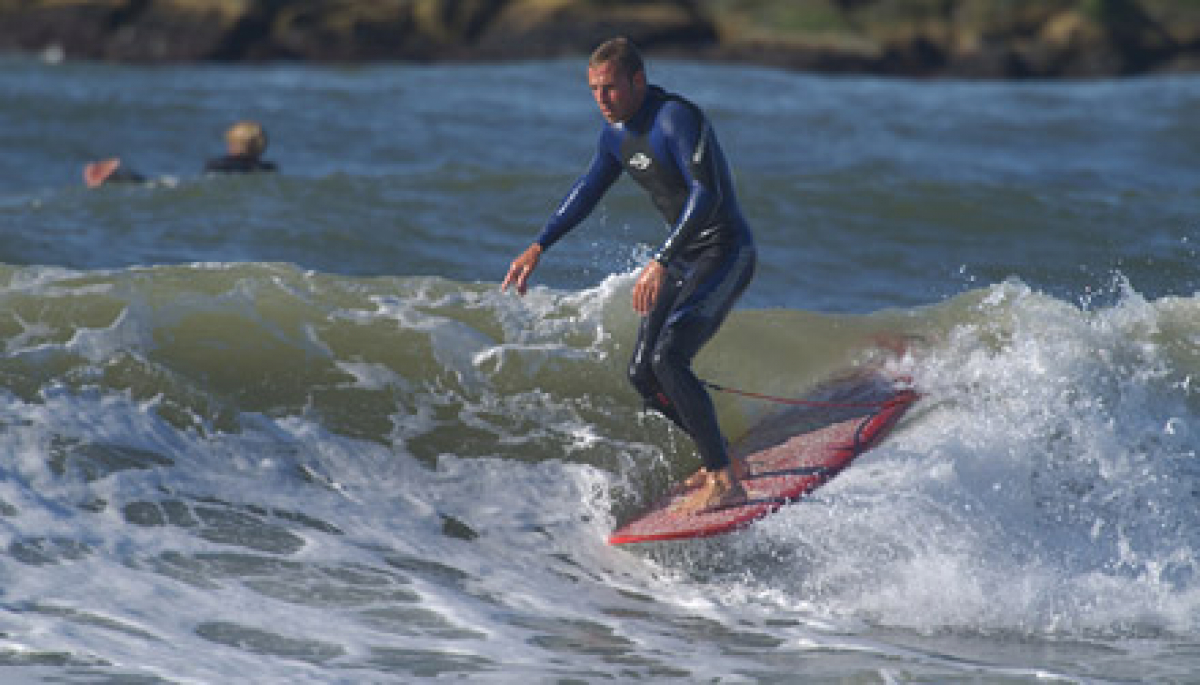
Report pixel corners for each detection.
[538,86,755,471]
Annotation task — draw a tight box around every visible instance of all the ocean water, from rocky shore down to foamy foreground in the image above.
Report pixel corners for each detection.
[0,58,1200,684]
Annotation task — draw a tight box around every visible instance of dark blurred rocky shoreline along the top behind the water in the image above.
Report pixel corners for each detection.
[0,0,1200,79]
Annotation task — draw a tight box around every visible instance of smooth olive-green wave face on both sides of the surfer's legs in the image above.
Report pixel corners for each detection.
[0,264,899,441]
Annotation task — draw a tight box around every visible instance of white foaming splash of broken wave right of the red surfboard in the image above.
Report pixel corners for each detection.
[686,281,1200,636]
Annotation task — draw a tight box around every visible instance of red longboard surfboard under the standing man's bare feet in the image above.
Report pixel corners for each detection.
[608,371,918,545]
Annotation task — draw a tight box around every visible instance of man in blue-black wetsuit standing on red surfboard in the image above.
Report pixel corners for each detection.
[500,38,756,512]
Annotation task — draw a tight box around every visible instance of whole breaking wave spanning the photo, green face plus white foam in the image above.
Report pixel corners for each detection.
[0,263,1200,633]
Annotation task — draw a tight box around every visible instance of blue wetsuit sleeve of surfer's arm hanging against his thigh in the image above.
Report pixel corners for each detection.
[654,102,721,264]
